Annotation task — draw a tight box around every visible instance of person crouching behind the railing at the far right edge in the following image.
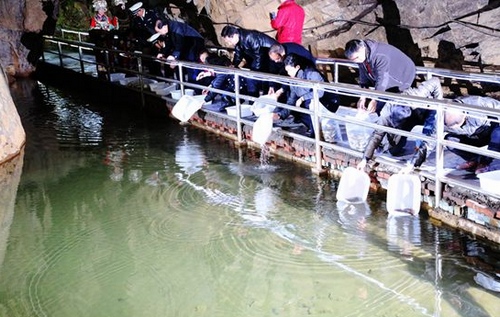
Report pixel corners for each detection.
[444,96,500,174]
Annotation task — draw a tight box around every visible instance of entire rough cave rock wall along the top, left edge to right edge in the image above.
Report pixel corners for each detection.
[0,0,500,76]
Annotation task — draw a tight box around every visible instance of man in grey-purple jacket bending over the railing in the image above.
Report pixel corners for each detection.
[345,40,415,113]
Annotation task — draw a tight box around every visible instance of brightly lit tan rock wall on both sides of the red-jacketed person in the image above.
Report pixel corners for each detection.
[203,0,500,64]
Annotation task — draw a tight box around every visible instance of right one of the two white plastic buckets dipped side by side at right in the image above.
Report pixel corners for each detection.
[386,174,422,215]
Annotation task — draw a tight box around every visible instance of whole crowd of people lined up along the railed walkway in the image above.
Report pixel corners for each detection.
[90,0,500,173]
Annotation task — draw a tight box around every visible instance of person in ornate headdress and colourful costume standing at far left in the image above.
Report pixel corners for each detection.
[89,0,118,78]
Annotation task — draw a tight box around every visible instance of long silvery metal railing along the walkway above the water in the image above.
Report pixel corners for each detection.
[43,37,500,203]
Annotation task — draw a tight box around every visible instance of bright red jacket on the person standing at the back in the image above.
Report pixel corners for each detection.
[271,0,305,44]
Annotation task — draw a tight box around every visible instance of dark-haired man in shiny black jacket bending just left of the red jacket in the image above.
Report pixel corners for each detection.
[221,25,277,97]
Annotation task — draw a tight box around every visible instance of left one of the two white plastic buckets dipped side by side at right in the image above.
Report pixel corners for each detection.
[337,167,370,204]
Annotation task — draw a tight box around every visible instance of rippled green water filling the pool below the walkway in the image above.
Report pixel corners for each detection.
[0,82,500,317]
